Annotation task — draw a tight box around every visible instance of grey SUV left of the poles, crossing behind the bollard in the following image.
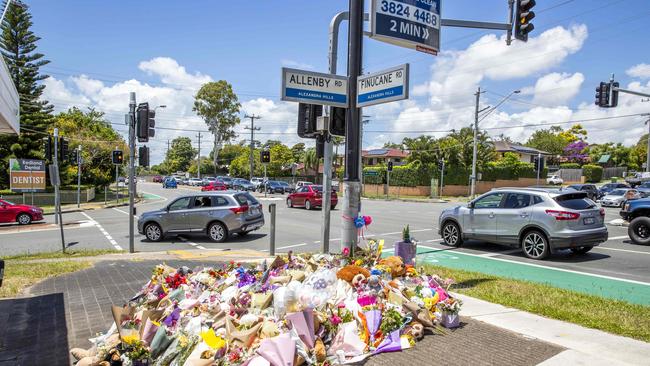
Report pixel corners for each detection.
[138,191,264,243]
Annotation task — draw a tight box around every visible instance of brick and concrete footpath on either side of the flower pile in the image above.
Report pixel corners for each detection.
[0,250,650,366]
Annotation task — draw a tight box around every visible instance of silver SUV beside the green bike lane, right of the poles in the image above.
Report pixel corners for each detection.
[438,188,608,259]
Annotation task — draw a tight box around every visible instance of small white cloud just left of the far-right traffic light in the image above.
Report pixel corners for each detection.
[533,72,585,105]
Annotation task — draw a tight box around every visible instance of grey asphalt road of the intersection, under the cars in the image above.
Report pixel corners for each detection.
[0,183,650,302]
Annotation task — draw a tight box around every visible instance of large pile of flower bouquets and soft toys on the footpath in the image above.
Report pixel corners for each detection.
[71,241,461,366]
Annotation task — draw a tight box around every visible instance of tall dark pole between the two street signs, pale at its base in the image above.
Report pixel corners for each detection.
[341,0,364,255]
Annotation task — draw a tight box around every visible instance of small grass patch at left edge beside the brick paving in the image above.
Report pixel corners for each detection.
[0,261,92,298]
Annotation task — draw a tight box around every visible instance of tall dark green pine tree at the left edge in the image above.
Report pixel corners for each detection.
[0,1,54,187]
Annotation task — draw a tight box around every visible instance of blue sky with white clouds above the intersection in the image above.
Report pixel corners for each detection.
[26,0,650,163]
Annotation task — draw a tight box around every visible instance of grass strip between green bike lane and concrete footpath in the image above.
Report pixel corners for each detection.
[424,265,650,342]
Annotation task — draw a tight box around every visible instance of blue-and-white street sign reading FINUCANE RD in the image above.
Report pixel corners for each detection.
[357,64,409,107]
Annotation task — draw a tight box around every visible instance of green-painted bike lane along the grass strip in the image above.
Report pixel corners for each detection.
[384,245,650,306]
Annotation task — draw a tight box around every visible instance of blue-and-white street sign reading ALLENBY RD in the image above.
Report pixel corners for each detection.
[282,67,349,108]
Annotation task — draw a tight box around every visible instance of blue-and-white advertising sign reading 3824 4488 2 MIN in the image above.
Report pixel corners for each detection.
[370,0,441,55]
